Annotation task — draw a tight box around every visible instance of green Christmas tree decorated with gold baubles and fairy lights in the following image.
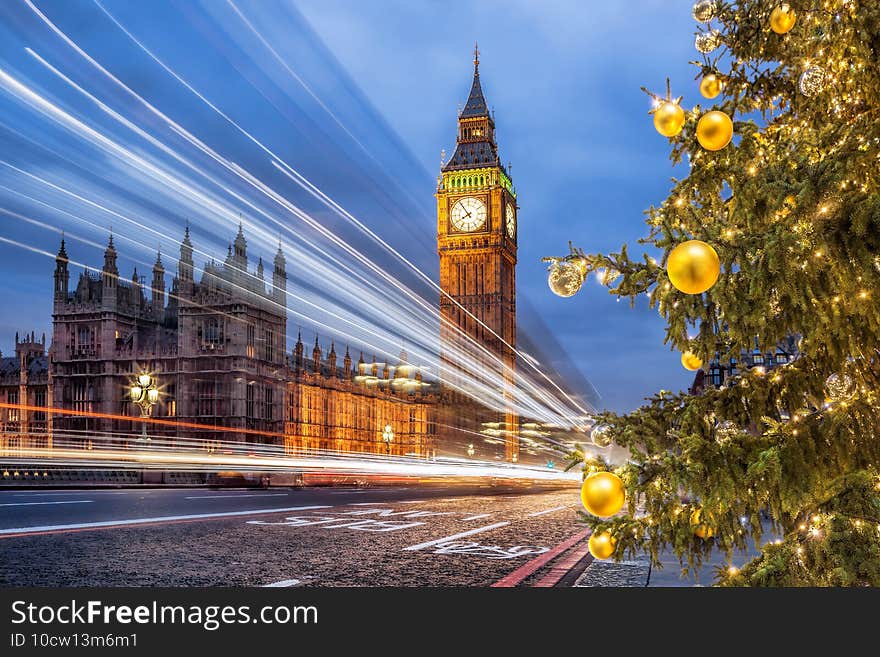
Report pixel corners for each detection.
[551,0,880,586]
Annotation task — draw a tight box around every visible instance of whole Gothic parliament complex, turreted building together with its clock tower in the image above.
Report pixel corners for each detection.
[0,50,519,461]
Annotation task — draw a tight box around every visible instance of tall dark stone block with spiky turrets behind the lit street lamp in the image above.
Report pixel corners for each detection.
[50,227,287,447]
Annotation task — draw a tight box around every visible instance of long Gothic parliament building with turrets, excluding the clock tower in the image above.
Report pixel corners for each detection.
[0,227,437,457]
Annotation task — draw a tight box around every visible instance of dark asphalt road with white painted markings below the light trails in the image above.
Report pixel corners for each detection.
[0,486,586,586]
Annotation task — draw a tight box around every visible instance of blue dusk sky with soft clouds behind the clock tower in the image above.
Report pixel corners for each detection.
[0,0,698,411]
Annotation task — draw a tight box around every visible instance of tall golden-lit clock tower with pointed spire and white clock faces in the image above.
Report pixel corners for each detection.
[437,47,519,461]
